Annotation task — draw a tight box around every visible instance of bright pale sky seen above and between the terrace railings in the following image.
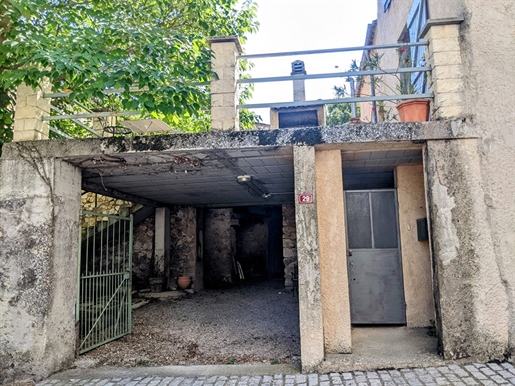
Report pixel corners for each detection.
[244,0,377,123]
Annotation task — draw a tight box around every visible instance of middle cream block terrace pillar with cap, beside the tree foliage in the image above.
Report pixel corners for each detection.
[209,36,242,131]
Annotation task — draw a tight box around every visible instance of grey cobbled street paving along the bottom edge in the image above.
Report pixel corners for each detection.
[37,362,515,386]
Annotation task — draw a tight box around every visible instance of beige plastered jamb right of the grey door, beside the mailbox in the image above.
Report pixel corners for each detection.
[395,165,435,327]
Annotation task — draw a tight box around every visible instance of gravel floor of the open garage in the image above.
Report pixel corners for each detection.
[81,280,300,366]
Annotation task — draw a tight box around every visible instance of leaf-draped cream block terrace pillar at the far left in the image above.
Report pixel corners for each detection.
[13,80,50,142]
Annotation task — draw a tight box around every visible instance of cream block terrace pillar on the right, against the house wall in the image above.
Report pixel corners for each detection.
[421,19,465,119]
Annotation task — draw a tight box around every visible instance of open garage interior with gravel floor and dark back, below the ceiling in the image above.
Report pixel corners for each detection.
[81,197,300,366]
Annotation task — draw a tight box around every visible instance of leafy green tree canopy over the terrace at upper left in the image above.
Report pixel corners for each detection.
[0,0,258,145]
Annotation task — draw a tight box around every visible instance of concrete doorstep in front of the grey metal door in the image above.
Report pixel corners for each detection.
[320,327,445,373]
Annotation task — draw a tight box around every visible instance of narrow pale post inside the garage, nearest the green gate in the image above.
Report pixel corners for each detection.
[154,208,170,287]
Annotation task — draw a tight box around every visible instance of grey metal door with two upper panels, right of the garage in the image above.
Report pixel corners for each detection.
[345,190,406,324]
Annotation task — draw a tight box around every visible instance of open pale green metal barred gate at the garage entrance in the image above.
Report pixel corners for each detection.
[76,211,133,354]
